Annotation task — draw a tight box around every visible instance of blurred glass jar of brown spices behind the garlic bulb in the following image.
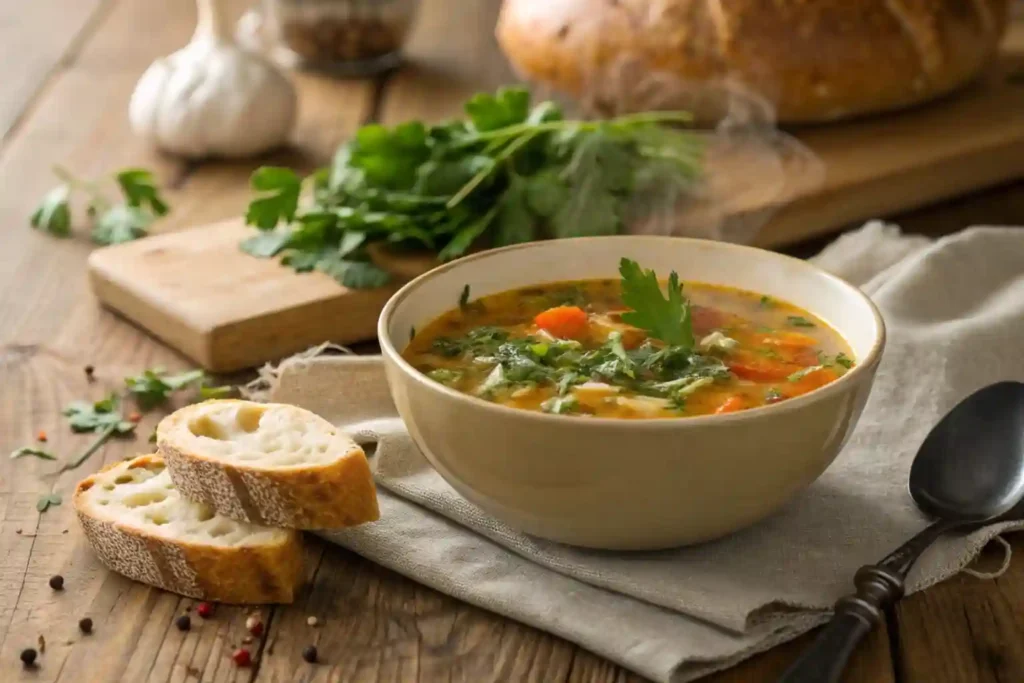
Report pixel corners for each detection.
[262,0,420,76]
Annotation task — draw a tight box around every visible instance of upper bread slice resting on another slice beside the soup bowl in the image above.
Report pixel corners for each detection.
[157,400,380,529]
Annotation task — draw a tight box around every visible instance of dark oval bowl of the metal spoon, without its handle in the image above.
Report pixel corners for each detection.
[909,382,1024,521]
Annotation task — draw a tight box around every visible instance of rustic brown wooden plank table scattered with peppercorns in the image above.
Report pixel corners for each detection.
[0,0,1024,683]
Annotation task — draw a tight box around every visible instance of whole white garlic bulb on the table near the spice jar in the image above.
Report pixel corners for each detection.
[128,0,296,159]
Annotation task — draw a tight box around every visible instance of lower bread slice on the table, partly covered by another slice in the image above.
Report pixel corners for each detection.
[74,456,302,604]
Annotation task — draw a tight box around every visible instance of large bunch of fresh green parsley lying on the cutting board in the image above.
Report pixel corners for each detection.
[242,88,700,289]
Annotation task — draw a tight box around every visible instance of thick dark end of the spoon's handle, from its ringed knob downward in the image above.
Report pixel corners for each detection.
[778,564,903,683]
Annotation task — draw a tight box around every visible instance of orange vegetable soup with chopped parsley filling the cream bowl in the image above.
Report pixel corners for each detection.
[403,259,854,419]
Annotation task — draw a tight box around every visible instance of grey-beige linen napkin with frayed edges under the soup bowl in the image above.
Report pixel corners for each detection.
[268,223,1024,682]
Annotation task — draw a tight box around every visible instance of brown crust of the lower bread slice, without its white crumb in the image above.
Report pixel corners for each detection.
[73,456,302,604]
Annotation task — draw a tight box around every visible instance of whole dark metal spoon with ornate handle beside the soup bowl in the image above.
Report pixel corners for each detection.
[779,382,1024,683]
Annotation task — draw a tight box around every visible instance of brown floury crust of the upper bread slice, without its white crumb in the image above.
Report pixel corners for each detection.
[157,400,380,529]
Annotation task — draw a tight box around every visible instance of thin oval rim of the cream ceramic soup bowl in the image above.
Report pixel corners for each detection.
[377,234,886,429]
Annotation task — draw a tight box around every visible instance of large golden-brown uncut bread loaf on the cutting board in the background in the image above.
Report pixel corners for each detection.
[497,0,1010,122]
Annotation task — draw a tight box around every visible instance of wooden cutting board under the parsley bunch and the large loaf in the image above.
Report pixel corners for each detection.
[89,29,1024,372]
